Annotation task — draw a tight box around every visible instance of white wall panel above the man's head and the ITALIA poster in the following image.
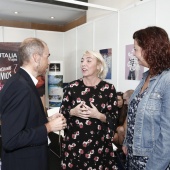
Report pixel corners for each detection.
[4,27,35,42]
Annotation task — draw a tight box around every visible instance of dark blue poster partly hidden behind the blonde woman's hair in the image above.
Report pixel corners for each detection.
[100,48,112,79]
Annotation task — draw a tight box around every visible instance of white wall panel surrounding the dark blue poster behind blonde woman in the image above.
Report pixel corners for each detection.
[94,12,118,87]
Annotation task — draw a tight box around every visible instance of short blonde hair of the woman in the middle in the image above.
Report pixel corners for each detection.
[84,51,108,80]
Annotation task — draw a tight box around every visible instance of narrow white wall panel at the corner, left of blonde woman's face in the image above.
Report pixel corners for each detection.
[64,28,77,83]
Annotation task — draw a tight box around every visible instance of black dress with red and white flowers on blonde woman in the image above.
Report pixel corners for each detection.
[61,79,118,170]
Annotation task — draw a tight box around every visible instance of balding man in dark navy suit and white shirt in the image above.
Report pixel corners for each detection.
[0,38,66,170]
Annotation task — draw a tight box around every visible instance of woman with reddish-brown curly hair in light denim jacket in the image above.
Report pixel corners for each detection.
[123,26,170,170]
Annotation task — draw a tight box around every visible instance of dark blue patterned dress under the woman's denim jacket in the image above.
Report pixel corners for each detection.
[125,89,170,170]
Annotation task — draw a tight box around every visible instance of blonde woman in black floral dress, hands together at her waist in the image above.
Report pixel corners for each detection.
[61,51,118,170]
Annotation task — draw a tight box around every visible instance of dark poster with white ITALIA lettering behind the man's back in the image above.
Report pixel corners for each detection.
[0,42,20,91]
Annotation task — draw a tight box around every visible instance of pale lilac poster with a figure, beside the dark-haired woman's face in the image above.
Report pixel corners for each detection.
[125,44,144,80]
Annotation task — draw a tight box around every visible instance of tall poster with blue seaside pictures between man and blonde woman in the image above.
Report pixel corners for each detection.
[48,62,63,108]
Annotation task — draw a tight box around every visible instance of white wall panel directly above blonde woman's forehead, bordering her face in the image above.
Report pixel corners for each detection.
[76,22,93,78]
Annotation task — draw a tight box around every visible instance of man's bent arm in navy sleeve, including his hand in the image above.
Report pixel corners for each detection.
[1,81,66,151]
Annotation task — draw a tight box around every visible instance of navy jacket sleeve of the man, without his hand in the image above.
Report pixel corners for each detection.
[2,82,47,151]
